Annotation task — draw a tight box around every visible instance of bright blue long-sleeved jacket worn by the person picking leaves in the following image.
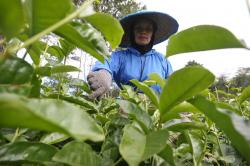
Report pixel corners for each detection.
[92,47,173,93]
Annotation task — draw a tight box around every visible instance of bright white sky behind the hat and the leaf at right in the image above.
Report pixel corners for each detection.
[136,0,250,78]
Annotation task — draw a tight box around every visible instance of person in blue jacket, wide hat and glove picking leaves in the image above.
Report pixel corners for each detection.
[87,11,179,98]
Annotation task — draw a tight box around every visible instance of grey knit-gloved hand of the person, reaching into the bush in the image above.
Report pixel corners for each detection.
[87,69,112,99]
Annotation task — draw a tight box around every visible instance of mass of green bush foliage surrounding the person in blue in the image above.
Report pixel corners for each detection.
[0,0,250,166]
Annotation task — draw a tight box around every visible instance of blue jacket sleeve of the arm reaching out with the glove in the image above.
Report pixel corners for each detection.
[92,52,121,77]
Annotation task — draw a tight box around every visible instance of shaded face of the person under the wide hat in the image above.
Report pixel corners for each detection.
[134,20,153,46]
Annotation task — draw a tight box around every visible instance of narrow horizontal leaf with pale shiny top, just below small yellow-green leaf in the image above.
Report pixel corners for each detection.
[163,119,206,131]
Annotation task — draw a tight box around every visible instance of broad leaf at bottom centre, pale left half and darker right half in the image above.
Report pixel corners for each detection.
[119,124,168,166]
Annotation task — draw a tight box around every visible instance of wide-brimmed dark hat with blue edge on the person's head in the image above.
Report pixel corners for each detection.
[120,11,179,47]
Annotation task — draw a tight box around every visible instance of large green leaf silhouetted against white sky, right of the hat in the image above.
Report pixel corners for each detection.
[166,25,245,56]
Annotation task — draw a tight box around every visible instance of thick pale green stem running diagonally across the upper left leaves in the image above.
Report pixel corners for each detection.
[18,0,94,51]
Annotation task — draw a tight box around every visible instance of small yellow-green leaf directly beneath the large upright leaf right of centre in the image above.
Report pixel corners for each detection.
[161,102,200,122]
